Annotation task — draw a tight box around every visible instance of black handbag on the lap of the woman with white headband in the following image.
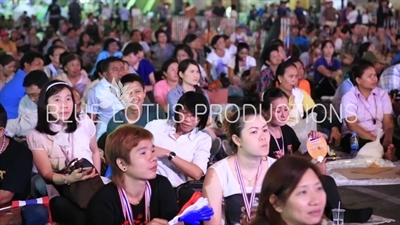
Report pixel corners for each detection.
[60,158,104,209]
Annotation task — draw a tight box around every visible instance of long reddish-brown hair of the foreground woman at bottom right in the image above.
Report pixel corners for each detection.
[250,155,322,225]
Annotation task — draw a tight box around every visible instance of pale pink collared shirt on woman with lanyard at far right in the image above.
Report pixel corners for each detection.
[341,87,393,135]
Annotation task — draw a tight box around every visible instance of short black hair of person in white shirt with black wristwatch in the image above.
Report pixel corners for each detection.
[174,91,210,130]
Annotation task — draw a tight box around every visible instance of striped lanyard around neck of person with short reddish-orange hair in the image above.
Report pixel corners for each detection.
[118,181,151,225]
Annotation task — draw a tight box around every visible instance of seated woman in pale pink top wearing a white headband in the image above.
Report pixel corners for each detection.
[26,80,101,225]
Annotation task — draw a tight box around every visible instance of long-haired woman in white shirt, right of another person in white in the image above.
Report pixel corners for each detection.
[228,43,257,96]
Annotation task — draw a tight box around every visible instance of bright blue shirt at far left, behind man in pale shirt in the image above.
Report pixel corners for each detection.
[0,69,26,119]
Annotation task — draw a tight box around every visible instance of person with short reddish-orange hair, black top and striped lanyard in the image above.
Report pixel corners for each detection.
[86,125,179,225]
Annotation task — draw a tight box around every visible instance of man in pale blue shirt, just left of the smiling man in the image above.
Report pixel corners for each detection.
[86,57,125,139]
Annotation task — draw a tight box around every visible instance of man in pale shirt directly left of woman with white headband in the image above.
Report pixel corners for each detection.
[6,70,49,137]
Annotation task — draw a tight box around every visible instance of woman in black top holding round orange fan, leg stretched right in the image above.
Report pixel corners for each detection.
[261,88,372,223]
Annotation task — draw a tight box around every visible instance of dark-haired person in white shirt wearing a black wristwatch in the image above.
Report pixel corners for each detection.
[145,91,212,187]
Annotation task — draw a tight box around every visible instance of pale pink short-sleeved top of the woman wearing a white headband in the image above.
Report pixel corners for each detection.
[26,114,96,171]
